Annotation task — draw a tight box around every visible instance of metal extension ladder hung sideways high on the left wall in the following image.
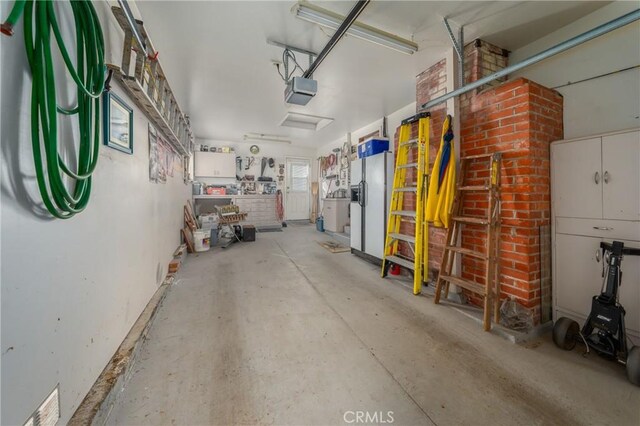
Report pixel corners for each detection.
[107,6,195,157]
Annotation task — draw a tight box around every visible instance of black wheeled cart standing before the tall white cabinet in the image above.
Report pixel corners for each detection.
[553,241,640,386]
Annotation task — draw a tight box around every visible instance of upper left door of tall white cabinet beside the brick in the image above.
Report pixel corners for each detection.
[551,138,602,218]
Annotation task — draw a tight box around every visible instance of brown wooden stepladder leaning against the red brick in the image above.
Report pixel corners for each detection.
[434,153,502,331]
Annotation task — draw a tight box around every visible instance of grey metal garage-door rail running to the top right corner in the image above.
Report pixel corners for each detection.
[420,9,640,109]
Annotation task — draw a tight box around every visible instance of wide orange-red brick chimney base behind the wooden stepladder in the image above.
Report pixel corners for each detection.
[460,79,563,321]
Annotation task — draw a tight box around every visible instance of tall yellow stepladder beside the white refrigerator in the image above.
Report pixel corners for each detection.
[381,112,430,294]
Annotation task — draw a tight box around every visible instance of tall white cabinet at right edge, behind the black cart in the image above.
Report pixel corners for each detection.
[551,130,640,344]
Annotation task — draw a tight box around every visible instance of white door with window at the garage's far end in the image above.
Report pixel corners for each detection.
[285,158,311,220]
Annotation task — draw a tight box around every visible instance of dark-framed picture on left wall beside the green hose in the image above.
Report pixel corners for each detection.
[102,92,133,154]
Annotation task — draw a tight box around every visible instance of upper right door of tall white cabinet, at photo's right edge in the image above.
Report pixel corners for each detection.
[602,132,640,220]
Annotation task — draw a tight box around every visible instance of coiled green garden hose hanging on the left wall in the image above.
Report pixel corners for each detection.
[2,0,106,219]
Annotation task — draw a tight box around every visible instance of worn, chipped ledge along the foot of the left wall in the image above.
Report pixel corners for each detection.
[68,278,173,426]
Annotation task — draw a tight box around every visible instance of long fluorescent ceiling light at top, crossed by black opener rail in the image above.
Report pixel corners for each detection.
[294,2,418,55]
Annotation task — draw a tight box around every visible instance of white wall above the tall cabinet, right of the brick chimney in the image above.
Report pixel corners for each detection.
[509,1,640,139]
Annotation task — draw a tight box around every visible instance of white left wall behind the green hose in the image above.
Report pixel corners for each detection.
[0,2,190,425]
